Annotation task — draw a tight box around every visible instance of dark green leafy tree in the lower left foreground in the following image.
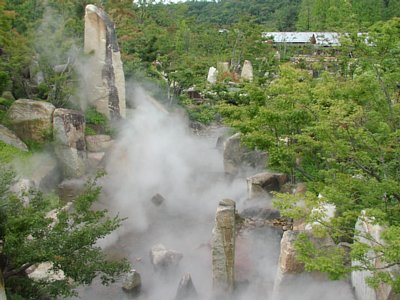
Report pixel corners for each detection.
[0,145,129,299]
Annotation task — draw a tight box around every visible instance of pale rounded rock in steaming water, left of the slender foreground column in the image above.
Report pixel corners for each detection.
[150,244,183,271]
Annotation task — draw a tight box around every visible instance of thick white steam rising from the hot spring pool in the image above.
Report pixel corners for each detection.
[81,84,353,300]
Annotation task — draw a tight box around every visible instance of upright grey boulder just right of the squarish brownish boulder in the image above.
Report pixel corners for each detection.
[53,108,87,178]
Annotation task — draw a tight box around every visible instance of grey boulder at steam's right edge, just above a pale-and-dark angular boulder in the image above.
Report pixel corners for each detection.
[223,133,267,176]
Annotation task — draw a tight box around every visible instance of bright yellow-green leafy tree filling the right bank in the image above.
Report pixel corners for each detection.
[222,19,400,293]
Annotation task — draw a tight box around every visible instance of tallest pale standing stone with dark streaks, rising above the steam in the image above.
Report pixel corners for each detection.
[84,4,126,120]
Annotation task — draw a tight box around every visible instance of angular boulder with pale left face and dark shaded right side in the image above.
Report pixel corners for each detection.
[247,172,288,199]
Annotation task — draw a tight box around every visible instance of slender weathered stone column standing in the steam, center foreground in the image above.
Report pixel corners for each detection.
[212,199,236,294]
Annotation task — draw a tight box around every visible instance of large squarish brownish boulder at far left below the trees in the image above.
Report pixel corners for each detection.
[8,99,55,143]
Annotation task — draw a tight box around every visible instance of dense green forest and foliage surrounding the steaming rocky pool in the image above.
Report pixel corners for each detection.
[0,0,400,299]
